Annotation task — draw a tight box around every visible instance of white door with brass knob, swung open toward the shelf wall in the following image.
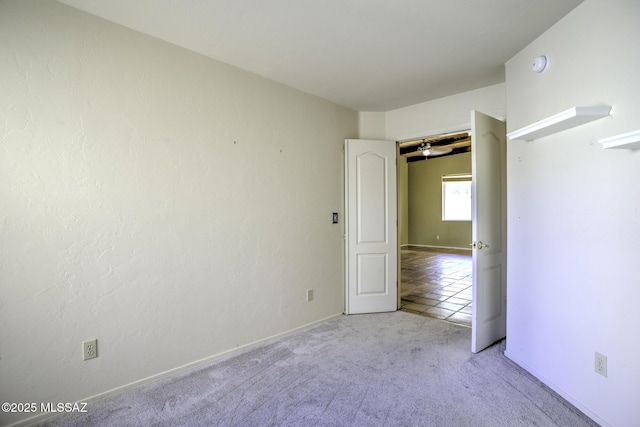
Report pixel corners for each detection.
[471,111,507,353]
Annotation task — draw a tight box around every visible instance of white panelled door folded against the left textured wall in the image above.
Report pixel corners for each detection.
[345,139,398,314]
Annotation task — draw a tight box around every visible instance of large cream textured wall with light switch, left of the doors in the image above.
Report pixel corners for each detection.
[0,0,358,425]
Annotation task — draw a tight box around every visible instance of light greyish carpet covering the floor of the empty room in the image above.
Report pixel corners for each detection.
[45,312,597,427]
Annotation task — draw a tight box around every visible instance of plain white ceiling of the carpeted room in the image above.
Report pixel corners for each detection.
[59,0,582,111]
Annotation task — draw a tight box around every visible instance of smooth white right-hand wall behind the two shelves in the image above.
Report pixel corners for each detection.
[506,0,640,426]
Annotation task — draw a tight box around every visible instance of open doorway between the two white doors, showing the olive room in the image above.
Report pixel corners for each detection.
[399,132,473,327]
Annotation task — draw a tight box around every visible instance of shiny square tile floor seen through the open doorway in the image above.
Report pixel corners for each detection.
[400,246,473,327]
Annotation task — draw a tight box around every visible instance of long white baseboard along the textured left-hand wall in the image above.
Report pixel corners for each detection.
[7,313,343,427]
